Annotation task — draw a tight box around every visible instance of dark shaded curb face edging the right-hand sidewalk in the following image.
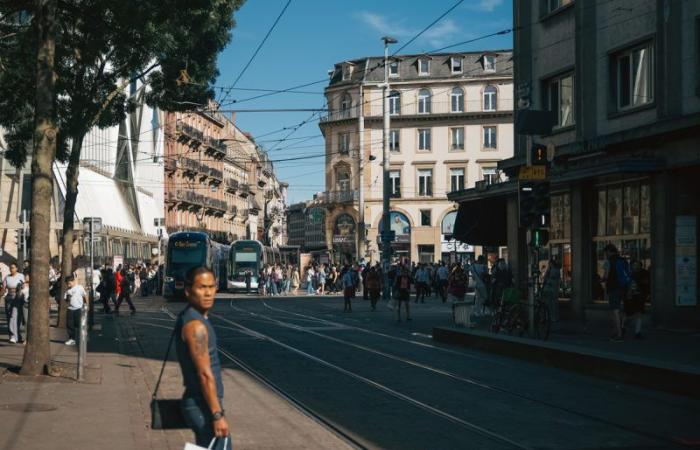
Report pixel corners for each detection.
[433,327,700,399]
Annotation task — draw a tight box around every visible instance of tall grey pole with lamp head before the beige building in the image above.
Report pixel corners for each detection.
[381,36,398,301]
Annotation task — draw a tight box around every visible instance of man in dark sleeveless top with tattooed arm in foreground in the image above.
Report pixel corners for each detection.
[173,267,232,450]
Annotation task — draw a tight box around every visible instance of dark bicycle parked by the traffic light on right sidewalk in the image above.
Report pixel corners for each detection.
[491,288,551,340]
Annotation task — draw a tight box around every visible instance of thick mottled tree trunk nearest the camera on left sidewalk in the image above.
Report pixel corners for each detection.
[21,0,57,375]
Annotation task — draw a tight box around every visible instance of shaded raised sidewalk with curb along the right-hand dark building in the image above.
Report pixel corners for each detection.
[433,298,700,398]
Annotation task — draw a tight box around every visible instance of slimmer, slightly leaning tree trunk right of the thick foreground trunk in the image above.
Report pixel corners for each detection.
[58,134,84,328]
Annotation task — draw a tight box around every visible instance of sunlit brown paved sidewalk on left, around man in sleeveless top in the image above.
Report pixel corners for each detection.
[0,298,348,450]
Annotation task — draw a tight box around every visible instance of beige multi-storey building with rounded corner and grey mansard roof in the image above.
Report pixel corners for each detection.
[316,50,513,262]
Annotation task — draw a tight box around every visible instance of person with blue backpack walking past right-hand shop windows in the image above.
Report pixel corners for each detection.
[603,244,631,342]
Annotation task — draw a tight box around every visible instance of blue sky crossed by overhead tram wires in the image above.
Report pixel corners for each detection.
[216,0,512,203]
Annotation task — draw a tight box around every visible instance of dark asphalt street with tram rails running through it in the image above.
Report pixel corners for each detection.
[137,294,700,449]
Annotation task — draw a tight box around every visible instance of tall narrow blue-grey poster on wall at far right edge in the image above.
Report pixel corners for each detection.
[676,216,698,306]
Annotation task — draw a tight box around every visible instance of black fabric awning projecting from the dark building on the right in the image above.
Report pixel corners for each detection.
[454,195,508,246]
